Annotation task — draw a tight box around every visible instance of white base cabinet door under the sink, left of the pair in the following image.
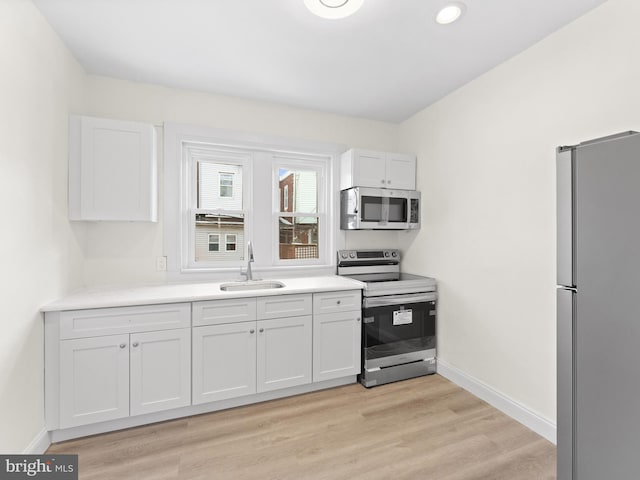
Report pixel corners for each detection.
[192,322,256,405]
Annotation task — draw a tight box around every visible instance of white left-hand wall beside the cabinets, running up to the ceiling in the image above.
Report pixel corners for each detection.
[0,0,84,453]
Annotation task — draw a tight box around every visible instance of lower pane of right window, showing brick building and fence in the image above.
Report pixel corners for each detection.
[278,217,319,260]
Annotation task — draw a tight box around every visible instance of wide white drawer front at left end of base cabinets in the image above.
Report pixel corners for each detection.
[60,303,191,339]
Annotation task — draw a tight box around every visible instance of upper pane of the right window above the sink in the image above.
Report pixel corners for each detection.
[278,168,318,213]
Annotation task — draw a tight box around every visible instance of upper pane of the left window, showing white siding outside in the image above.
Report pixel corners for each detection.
[197,160,242,210]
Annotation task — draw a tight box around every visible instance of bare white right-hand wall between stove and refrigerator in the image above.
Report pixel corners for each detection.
[399,0,640,422]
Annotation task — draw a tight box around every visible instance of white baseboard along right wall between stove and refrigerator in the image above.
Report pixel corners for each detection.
[437,358,556,445]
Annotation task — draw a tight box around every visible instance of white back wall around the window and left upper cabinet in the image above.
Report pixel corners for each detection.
[77,76,398,285]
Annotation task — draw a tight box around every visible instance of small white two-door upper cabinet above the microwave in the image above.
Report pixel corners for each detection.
[340,149,416,190]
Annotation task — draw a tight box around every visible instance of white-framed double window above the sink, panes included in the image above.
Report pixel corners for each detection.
[163,124,343,280]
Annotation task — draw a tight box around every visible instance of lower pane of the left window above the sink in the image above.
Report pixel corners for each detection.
[195,213,244,262]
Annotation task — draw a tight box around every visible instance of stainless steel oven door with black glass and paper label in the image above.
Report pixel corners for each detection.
[362,293,436,369]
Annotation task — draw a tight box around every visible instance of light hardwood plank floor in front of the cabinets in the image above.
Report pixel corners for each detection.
[47,375,556,480]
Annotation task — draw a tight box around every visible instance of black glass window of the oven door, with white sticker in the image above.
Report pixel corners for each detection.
[362,301,436,360]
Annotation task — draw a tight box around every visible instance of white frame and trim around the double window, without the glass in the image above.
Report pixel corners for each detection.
[162,123,347,281]
